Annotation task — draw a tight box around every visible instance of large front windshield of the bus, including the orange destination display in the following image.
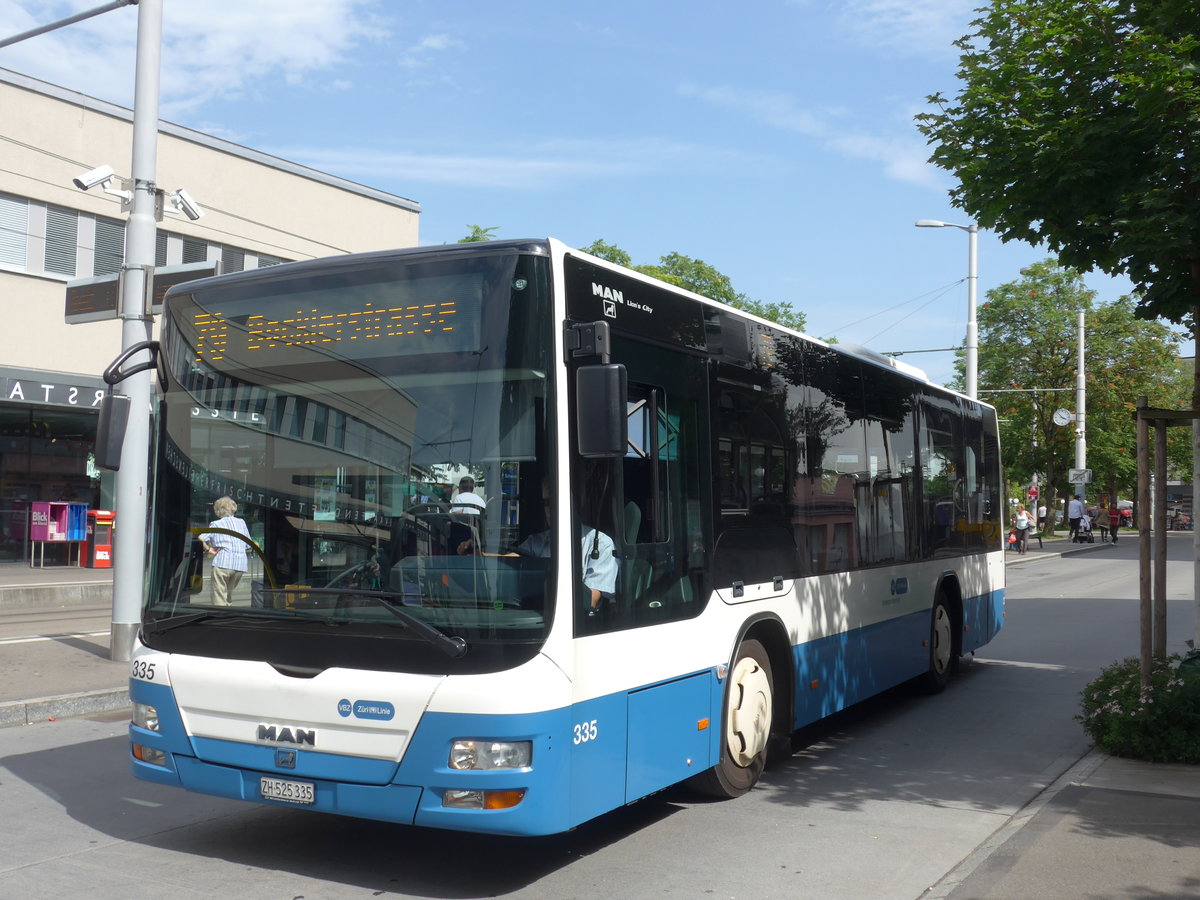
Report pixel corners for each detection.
[143,250,553,671]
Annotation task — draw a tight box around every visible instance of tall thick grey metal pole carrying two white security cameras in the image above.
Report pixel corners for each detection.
[109,0,162,661]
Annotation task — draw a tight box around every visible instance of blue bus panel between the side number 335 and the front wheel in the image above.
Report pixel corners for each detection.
[625,672,720,803]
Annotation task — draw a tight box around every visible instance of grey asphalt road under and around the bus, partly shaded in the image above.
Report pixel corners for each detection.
[0,535,1193,900]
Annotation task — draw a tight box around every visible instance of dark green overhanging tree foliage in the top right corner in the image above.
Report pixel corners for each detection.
[917,0,1200,329]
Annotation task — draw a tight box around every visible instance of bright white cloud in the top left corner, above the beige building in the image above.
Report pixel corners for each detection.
[0,0,388,112]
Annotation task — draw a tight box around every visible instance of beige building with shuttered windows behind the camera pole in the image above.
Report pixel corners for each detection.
[0,70,420,564]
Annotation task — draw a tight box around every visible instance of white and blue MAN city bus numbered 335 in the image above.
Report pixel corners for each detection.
[121,240,1004,835]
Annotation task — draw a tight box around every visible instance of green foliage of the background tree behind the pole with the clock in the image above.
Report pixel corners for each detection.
[979,259,1192,511]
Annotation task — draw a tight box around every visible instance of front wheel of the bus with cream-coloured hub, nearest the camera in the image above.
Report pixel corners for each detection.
[691,640,775,799]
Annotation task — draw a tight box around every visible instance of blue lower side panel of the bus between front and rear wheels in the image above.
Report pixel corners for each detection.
[793,611,930,728]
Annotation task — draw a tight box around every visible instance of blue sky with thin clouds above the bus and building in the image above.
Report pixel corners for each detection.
[0,0,1156,382]
